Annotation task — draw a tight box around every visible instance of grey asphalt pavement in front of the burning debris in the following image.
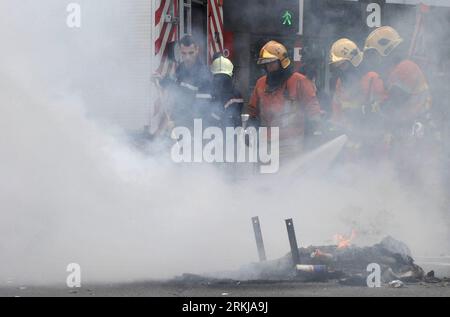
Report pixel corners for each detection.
[0,256,450,297]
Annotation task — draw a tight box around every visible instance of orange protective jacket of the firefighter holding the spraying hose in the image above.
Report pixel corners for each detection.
[249,73,321,140]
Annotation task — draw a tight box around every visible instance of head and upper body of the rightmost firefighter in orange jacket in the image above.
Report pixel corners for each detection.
[364,26,434,135]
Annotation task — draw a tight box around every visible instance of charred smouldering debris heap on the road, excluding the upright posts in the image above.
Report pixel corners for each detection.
[237,232,426,285]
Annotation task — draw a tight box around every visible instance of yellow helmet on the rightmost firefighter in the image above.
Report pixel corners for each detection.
[364,26,403,56]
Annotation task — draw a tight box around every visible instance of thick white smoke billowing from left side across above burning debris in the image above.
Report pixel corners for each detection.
[0,0,447,285]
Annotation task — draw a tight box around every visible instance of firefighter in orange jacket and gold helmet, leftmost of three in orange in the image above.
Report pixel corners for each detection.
[248,41,321,158]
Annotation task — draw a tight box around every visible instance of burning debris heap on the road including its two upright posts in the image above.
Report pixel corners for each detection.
[212,217,439,287]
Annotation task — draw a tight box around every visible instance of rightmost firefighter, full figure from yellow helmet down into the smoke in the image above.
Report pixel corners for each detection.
[364,26,440,183]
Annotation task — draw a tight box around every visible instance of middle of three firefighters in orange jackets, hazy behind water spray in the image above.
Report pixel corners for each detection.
[330,38,386,160]
